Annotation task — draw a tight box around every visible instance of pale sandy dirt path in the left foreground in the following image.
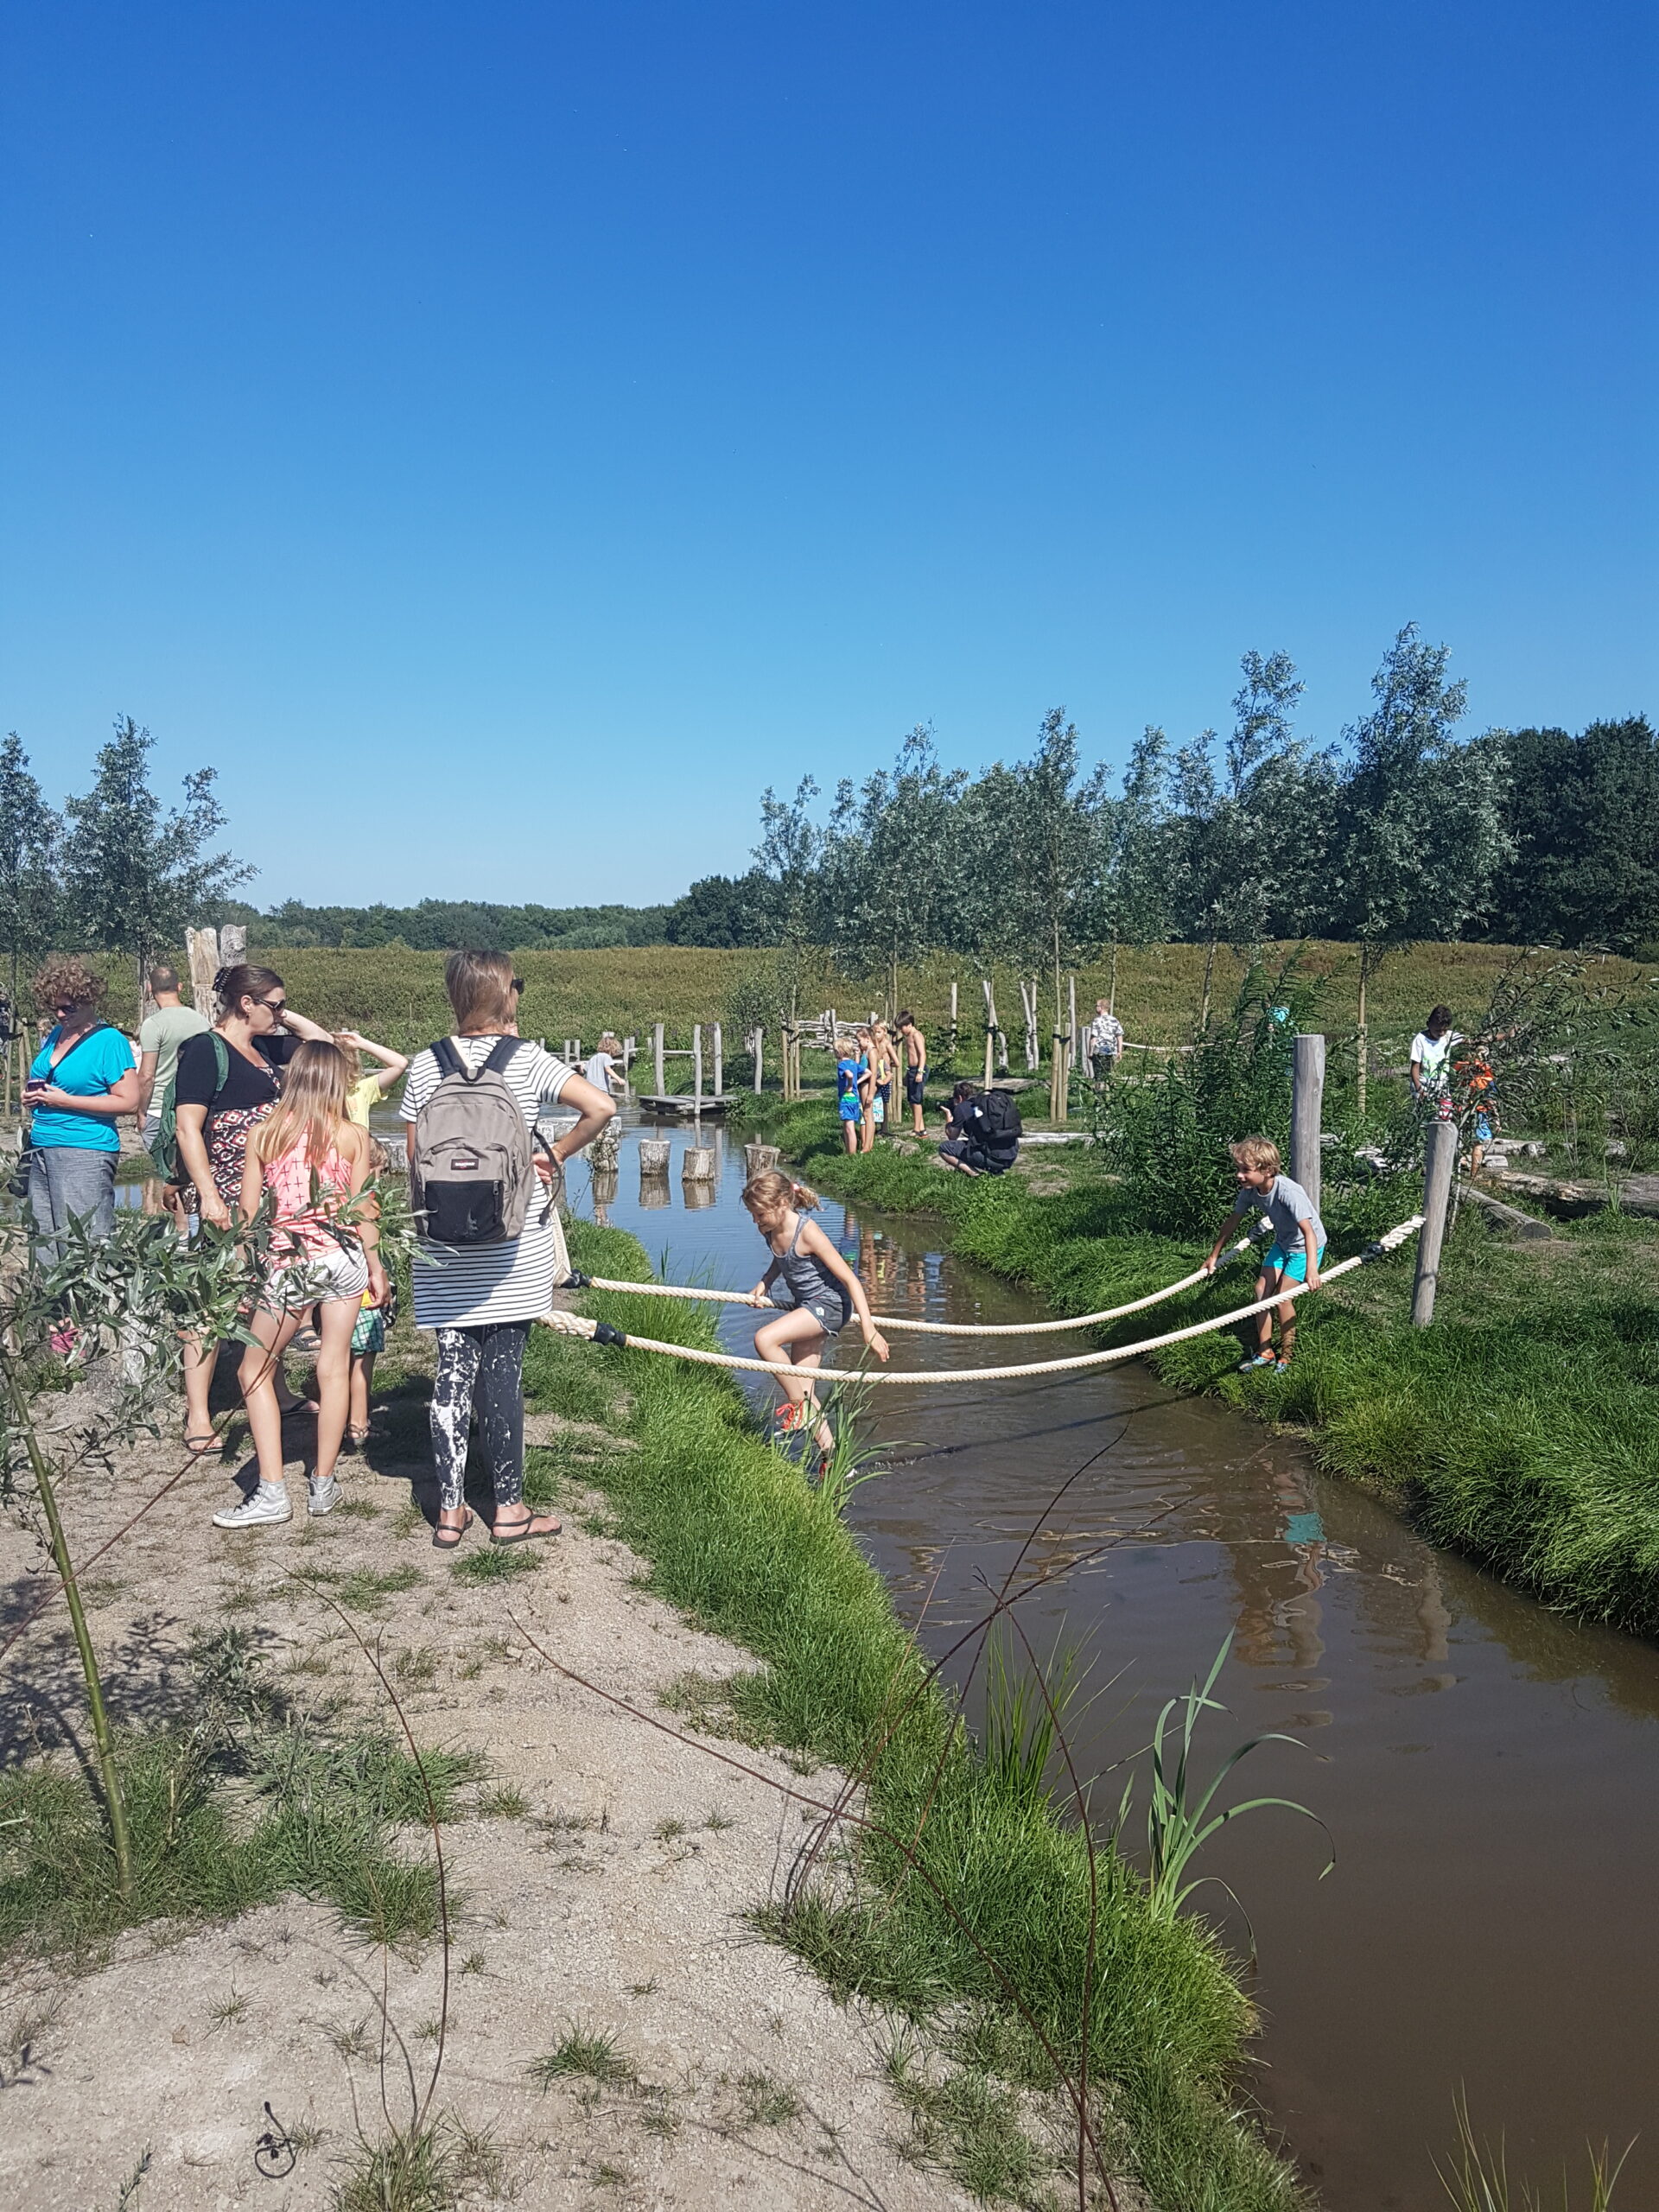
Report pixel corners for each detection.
[0,1371,982,2212]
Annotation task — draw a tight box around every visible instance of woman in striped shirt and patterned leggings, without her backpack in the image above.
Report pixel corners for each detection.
[400,953,617,1551]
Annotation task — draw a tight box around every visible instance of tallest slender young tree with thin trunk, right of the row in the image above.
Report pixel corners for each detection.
[1334,621,1509,1117]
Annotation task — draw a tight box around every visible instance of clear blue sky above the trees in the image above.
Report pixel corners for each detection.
[0,0,1659,905]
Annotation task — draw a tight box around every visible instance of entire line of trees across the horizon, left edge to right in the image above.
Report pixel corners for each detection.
[0,626,1659,1027]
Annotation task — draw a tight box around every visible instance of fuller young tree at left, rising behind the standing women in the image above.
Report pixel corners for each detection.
[64,715,254,1007]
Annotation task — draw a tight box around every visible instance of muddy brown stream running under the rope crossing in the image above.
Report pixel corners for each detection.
[570,1130,1659,2212]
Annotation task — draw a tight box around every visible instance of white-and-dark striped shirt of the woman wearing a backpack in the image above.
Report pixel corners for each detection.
[398,1038,575,1330]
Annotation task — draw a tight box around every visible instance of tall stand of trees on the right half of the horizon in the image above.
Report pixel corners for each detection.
[666,626,1659,973]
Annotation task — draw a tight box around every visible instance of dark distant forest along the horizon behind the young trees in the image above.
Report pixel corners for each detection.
[221,715,1659,957]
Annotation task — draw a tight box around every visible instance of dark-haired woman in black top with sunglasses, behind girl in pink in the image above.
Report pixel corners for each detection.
[173,967,329,1451]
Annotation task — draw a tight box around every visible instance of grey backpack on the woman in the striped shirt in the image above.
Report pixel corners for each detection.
[410,1038,553,1245]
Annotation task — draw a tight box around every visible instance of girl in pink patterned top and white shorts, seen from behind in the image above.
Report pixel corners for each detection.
[213,1044,385,1529]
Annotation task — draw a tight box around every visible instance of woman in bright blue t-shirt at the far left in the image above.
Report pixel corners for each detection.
[22,960,139,1263]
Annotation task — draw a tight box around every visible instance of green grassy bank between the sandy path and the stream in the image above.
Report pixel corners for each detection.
[542,1224,1300,2212]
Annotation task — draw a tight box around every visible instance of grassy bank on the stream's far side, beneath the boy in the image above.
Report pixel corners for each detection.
[774,1106,1659,1635]
